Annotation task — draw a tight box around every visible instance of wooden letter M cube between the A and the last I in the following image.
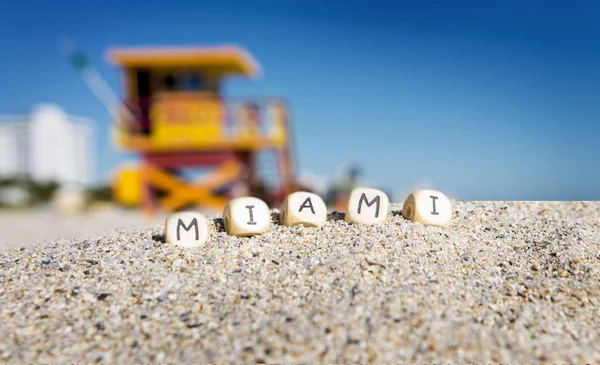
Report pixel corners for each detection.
[345,188,390,224]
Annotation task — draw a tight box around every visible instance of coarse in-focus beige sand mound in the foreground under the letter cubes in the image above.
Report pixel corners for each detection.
[0,201,600,363]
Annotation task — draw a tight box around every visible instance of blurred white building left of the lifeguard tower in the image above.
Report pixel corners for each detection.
[0,105,96,186]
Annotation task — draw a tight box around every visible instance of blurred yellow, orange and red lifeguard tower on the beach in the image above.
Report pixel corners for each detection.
[108,46,297,213]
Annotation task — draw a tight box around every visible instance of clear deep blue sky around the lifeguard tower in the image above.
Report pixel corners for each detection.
[0,0,600,200]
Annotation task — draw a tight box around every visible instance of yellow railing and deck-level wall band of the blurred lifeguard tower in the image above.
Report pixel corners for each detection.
[114,93,289,151]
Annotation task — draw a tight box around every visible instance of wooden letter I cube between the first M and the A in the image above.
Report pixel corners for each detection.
[223,197,271,237]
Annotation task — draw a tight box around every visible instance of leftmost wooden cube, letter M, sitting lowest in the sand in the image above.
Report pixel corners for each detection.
[164,212,208,247]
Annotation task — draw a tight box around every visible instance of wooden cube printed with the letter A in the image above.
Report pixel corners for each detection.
[279,191,327,227]
